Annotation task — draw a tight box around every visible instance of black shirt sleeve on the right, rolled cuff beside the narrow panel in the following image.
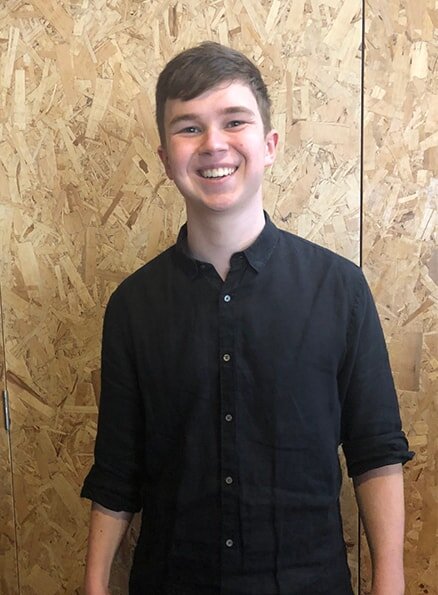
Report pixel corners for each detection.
[338,272,414,477]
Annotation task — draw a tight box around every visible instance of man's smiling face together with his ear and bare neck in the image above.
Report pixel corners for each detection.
[158,80,278,280]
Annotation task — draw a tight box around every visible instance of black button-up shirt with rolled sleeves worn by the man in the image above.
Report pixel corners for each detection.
[82,218,411,595]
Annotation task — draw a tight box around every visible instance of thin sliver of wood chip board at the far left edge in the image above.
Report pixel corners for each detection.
[0,286,18,595]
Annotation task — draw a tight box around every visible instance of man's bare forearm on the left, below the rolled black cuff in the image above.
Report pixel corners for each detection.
[84,502,132,595]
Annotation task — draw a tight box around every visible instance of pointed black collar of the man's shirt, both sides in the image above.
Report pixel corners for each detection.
[175,211,279,278]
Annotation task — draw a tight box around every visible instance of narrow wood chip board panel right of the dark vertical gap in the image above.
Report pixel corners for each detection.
[362,0,438,595]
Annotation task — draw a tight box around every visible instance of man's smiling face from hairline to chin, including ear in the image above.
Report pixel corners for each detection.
[158,82,278,217]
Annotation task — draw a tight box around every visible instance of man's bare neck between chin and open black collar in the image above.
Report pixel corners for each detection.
[187,205,265,280]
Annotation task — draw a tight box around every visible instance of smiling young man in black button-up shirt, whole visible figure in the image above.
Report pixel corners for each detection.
[82,43,411,595]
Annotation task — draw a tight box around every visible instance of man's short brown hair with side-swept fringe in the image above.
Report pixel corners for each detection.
[155,41,272,144]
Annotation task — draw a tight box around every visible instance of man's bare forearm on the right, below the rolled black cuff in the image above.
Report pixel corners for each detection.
[353,463,405,595]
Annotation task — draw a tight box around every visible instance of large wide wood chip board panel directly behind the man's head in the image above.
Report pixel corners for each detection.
[0,0,361,595]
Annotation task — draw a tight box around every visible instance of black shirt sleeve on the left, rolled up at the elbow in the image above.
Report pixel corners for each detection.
[81,291,144,512]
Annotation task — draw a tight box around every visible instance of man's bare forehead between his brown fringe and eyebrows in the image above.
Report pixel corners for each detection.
[164,81,261,125]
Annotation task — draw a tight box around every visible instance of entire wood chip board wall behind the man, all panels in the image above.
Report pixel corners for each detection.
[0,0,438,595]
